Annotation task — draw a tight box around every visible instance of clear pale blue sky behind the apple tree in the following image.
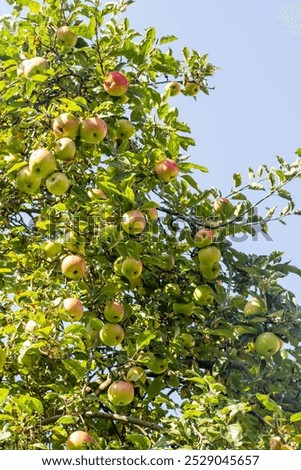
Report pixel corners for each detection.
[0,0,301,302]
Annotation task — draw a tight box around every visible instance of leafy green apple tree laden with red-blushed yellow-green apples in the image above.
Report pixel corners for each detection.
[0,0,301,449]
